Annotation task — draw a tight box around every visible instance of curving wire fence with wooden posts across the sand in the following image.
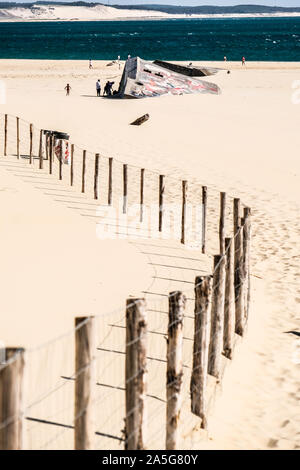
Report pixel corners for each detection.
[0,115,250,449]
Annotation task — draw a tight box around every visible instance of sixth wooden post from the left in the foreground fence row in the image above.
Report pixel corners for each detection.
[208,255,225,378]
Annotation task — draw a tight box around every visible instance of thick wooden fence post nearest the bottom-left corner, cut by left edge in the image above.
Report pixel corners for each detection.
[0,348,25,450]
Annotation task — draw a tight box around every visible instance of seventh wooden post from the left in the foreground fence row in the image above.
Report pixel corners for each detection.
[223,238,235,359]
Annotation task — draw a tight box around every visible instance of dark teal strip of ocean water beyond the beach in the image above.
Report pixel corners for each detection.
[0,17,300,61]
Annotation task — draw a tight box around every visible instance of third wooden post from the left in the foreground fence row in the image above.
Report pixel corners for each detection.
[125,299,147,450]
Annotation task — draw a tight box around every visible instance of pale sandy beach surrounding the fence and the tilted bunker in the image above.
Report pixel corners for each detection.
[0,60,300,449]
